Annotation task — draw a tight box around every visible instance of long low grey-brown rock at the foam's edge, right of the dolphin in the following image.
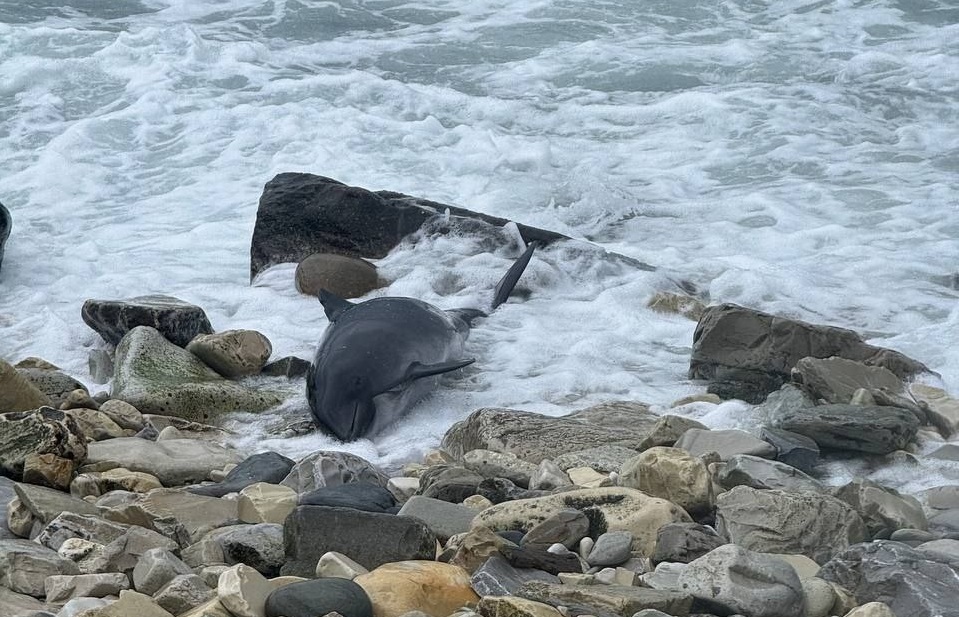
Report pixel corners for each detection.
[442,406,659,464]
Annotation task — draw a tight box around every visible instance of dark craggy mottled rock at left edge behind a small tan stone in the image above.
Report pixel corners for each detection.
[0,407,87,488]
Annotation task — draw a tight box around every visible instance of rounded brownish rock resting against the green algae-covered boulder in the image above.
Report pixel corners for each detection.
[186,330,273,379]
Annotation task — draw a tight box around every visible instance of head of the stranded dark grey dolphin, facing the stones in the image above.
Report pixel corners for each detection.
[307,367,376,441]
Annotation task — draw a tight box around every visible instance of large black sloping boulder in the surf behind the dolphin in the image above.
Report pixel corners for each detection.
[250,173,567,280]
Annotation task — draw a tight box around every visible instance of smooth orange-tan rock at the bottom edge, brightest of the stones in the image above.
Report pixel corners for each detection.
[356,561,479,617]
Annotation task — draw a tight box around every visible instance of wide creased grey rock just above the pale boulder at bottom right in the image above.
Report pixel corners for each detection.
[716,486,866,564]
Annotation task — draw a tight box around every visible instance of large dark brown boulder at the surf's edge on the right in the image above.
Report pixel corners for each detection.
[689,304,930,403]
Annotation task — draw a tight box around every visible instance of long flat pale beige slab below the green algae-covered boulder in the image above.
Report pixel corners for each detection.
[87,437,241,486]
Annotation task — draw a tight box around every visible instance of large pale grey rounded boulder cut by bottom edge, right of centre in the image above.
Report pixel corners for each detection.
[679,544,805,617]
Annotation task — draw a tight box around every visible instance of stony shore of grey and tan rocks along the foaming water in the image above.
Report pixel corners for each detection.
[0,174,959,617]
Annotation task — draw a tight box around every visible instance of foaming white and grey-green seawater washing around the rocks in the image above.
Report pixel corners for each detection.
[0,0,959,489]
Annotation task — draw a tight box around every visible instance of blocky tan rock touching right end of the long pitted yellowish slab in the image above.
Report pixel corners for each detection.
[619,446,712,514]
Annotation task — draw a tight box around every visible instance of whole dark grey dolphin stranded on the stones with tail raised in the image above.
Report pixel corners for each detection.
[306,244,535,441]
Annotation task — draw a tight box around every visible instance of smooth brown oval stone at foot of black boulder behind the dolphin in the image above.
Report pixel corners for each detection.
[295,253,381,298]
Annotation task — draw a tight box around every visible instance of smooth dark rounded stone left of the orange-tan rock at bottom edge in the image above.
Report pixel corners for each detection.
[266,578,373,617]
